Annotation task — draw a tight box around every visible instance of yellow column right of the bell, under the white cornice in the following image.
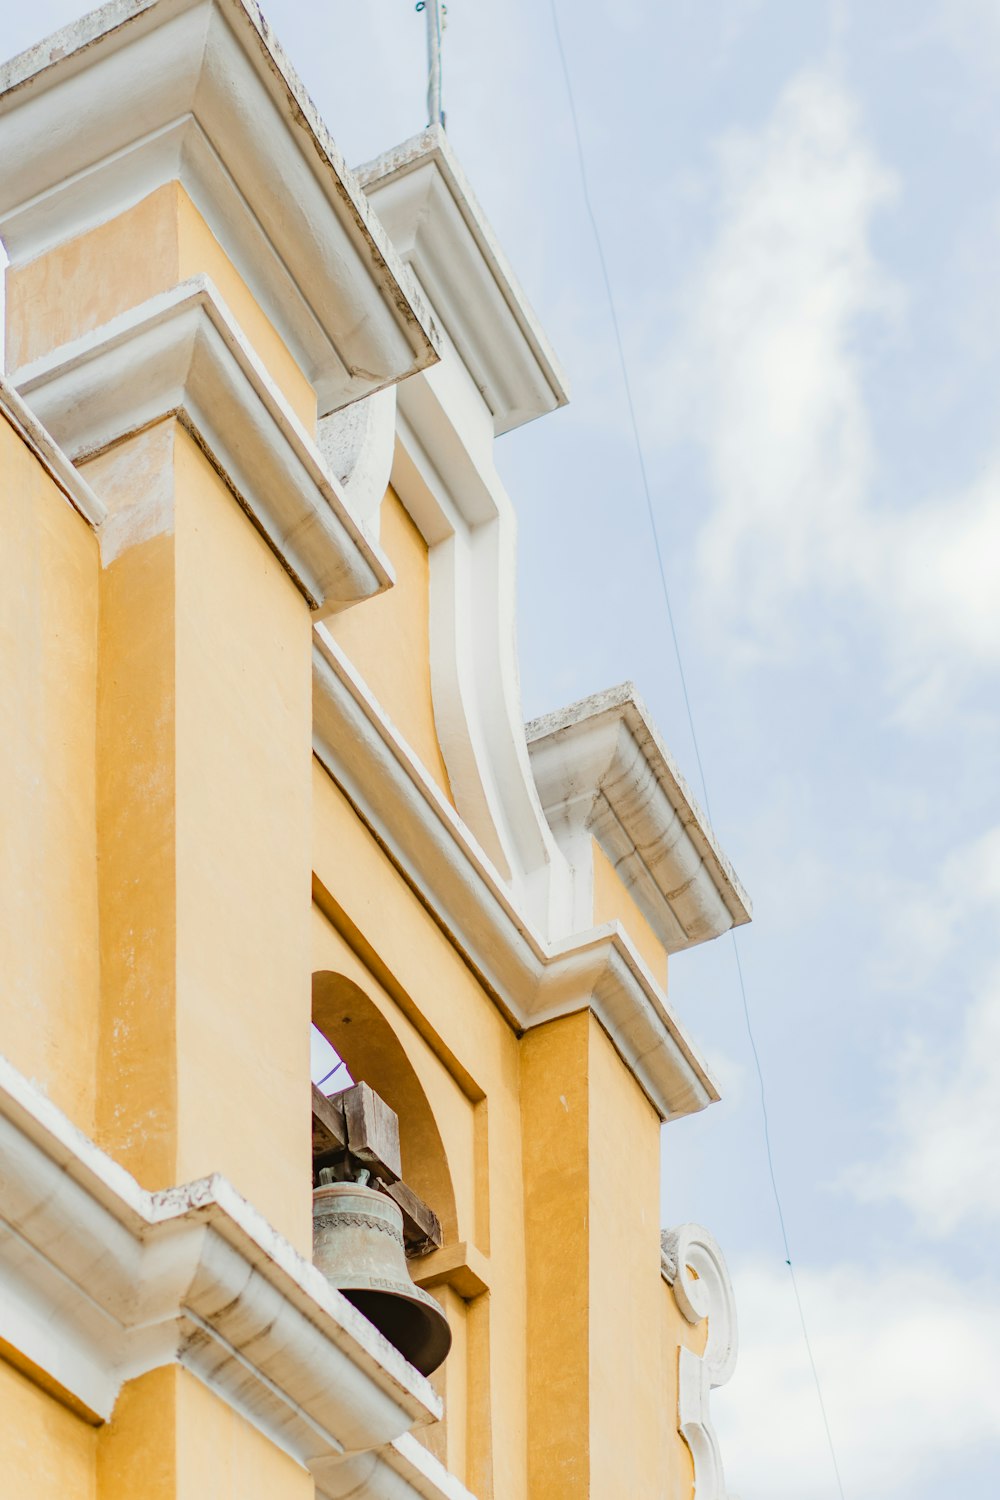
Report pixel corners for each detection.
[522,1013,667,1500]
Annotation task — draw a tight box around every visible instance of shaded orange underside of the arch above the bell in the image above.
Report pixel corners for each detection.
[312,971,459,1245]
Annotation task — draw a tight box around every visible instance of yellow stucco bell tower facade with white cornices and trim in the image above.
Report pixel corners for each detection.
[0,0,750,1500]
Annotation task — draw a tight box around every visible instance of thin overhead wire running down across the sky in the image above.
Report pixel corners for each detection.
[549,0,846,1500]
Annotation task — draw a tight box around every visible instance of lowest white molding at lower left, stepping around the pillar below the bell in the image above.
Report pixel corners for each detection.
[0,1058,462,1497]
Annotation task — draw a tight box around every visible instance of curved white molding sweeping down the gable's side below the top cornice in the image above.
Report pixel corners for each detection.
[393,393,569,935]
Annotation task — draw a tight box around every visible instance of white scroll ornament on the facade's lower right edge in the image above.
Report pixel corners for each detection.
[660,1224,736,1500]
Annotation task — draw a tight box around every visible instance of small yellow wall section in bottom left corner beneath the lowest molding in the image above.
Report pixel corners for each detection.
[0,1359,96,1500]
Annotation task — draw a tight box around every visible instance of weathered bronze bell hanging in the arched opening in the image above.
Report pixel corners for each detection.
[312,1182,451,1376]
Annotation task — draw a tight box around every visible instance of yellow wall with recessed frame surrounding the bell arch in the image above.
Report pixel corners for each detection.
[313,764,528,1500]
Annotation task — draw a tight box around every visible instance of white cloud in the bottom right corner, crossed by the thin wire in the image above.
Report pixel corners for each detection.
[714,1263,1000,1500]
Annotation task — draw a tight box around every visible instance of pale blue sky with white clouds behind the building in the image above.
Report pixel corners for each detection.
[3,0,1000,1500]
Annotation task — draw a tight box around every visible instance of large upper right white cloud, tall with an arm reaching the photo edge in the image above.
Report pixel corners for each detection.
[669,60,1000,690]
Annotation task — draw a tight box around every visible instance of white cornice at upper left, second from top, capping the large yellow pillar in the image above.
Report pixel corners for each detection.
[10,276,391,612]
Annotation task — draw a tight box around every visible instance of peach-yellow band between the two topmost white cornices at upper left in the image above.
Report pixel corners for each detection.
[6,182,316,434]
